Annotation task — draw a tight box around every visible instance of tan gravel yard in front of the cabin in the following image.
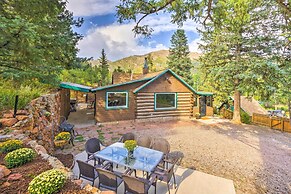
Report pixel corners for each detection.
[63,119,291,194]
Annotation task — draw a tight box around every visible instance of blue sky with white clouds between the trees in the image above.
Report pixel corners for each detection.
[67,0,200,61]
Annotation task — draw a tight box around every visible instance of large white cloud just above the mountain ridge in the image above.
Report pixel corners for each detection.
[78,24,167,60]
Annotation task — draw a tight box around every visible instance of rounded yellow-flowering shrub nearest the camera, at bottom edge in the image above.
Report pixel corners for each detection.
[28,169,66,194]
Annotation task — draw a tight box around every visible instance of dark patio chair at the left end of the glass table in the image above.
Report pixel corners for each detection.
[85,138,102,166]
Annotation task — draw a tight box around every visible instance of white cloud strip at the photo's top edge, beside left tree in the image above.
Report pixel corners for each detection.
[67,0,118,16]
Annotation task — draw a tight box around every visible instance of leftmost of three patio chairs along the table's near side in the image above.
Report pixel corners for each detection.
[76,160,98,186]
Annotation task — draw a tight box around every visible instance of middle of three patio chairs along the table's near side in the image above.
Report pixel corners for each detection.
[96,163,123,193]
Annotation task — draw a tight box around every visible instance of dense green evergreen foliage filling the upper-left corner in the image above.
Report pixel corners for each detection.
[0,0,82,84]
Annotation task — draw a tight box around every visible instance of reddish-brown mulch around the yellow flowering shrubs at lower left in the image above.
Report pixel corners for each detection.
[0,149,89,194]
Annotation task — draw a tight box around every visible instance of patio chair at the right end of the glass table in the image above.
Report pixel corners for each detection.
[153,160,177,194]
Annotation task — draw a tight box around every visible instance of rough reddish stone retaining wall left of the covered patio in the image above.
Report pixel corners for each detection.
[0,92,61,154]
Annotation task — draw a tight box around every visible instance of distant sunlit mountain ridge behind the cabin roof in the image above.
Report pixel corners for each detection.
[91,50,201,73]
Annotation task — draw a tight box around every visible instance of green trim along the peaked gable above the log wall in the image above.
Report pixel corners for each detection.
[133,69,213,96]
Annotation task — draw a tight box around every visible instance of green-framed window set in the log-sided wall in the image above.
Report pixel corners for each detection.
[155,93,177,110]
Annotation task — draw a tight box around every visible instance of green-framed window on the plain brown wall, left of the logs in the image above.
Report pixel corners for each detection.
[106,92,128,109]
